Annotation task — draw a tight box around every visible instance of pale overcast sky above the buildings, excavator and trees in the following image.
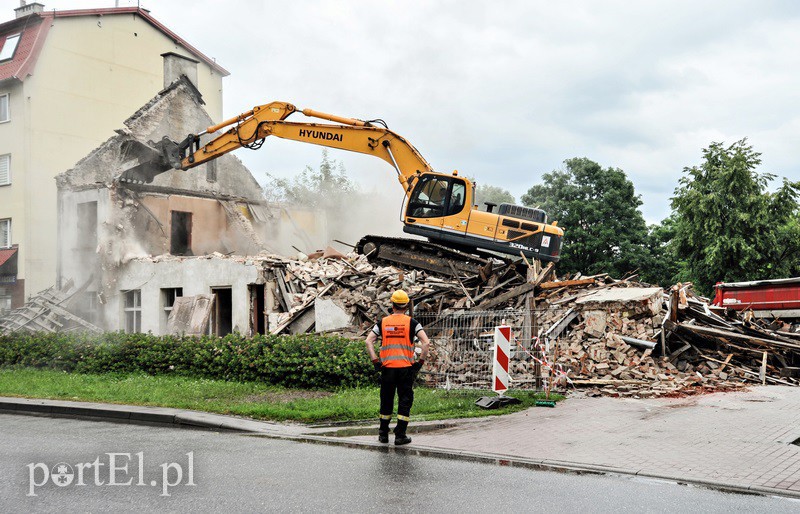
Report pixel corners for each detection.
[10,0,800,223]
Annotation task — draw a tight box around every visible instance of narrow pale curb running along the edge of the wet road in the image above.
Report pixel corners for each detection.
[0,397,800,499]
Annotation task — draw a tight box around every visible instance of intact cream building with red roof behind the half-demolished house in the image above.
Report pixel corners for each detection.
[0,1,228,309]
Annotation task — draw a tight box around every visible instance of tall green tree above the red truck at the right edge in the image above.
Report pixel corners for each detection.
[672,139,800,293]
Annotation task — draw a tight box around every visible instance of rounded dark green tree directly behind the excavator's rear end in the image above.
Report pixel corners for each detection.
[522,158,648,277]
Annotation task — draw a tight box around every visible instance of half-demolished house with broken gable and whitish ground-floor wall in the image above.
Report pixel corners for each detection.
[57,70,282,335]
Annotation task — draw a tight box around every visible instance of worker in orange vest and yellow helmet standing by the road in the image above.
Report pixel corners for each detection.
[366,289,430,446]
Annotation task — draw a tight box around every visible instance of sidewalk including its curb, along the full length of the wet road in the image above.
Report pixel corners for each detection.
[0,386,800,498]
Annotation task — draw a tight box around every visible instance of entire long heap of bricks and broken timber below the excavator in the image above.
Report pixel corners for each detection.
[245,247,800,397]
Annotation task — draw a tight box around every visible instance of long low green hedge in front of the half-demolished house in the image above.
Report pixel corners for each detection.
[0,332,376,389]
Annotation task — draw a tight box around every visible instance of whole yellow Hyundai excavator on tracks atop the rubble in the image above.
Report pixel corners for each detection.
[120,102,564,274]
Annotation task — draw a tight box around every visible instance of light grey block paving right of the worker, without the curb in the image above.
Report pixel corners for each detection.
[348,386,800,496]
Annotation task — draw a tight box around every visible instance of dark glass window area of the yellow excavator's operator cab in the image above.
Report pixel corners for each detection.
[407,175,467,218]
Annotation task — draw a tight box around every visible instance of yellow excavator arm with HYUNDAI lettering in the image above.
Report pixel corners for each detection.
[134,102,433,195]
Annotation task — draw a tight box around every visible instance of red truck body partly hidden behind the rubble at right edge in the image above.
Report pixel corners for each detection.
[711,277,800,324]
